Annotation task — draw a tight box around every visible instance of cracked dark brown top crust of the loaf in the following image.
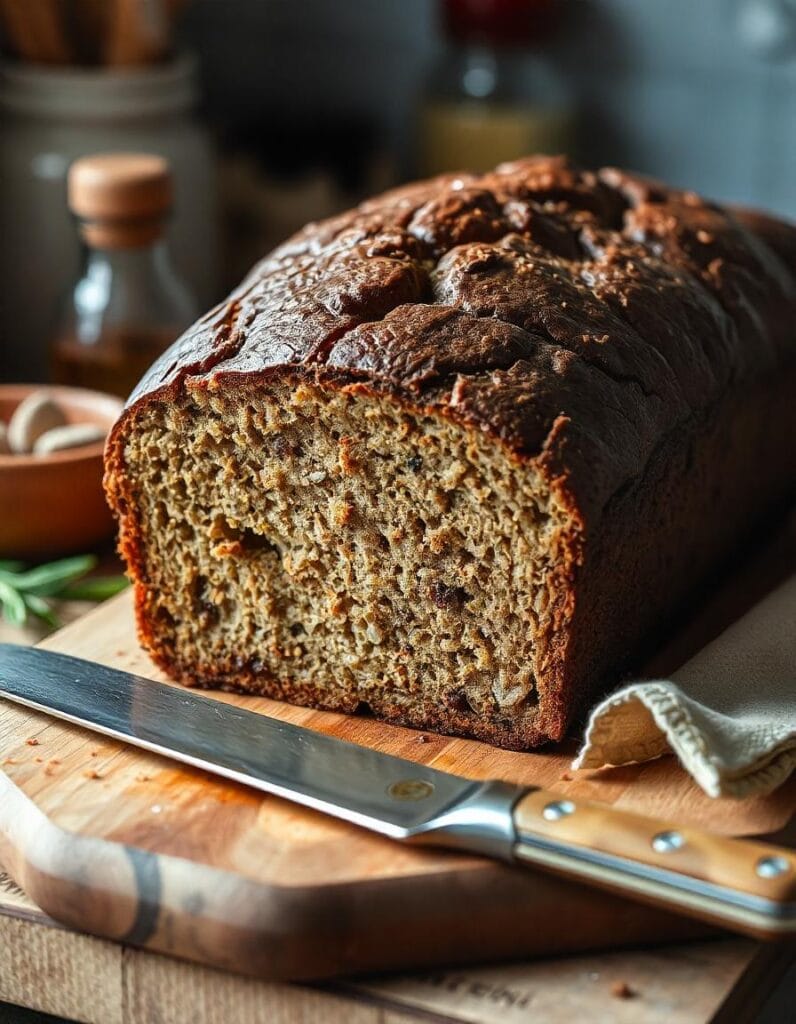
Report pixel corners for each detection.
[123,157,796,520]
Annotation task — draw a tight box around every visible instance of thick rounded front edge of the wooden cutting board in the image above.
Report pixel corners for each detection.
[0,772,712,980]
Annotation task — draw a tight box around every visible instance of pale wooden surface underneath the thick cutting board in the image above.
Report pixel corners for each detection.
[0,528,796,1024]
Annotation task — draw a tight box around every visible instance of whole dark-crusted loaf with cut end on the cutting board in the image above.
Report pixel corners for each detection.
[106,157,796,749]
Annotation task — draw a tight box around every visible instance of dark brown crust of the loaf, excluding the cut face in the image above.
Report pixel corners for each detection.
[107,158,796,748]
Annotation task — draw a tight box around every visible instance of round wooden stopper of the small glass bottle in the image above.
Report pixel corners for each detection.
[68,153,172,249]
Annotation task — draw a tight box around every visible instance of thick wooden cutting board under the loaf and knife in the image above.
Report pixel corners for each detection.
[0,581,796,978]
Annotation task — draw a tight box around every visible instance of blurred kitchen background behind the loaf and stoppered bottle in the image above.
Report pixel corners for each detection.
[0,0,796,381]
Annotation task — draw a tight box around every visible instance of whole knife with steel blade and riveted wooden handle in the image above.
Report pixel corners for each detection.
[0,644,796,938]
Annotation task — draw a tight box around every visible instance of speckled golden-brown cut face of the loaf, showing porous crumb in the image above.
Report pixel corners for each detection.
[113,382,570,746]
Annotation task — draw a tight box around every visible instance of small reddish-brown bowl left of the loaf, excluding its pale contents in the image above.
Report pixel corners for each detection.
[0,384,123,560]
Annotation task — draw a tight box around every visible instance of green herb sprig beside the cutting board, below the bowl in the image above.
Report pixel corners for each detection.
[0,555,128,629]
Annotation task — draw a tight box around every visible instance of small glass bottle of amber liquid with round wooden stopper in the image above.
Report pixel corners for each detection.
[51,153,198,395]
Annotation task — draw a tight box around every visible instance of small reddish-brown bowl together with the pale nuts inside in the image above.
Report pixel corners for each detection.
[0,384,123,559]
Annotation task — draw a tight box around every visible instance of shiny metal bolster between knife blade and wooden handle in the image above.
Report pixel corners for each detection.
[407,781,529,861]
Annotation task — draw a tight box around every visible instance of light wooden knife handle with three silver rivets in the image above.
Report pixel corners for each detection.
[512,790,796,938]
